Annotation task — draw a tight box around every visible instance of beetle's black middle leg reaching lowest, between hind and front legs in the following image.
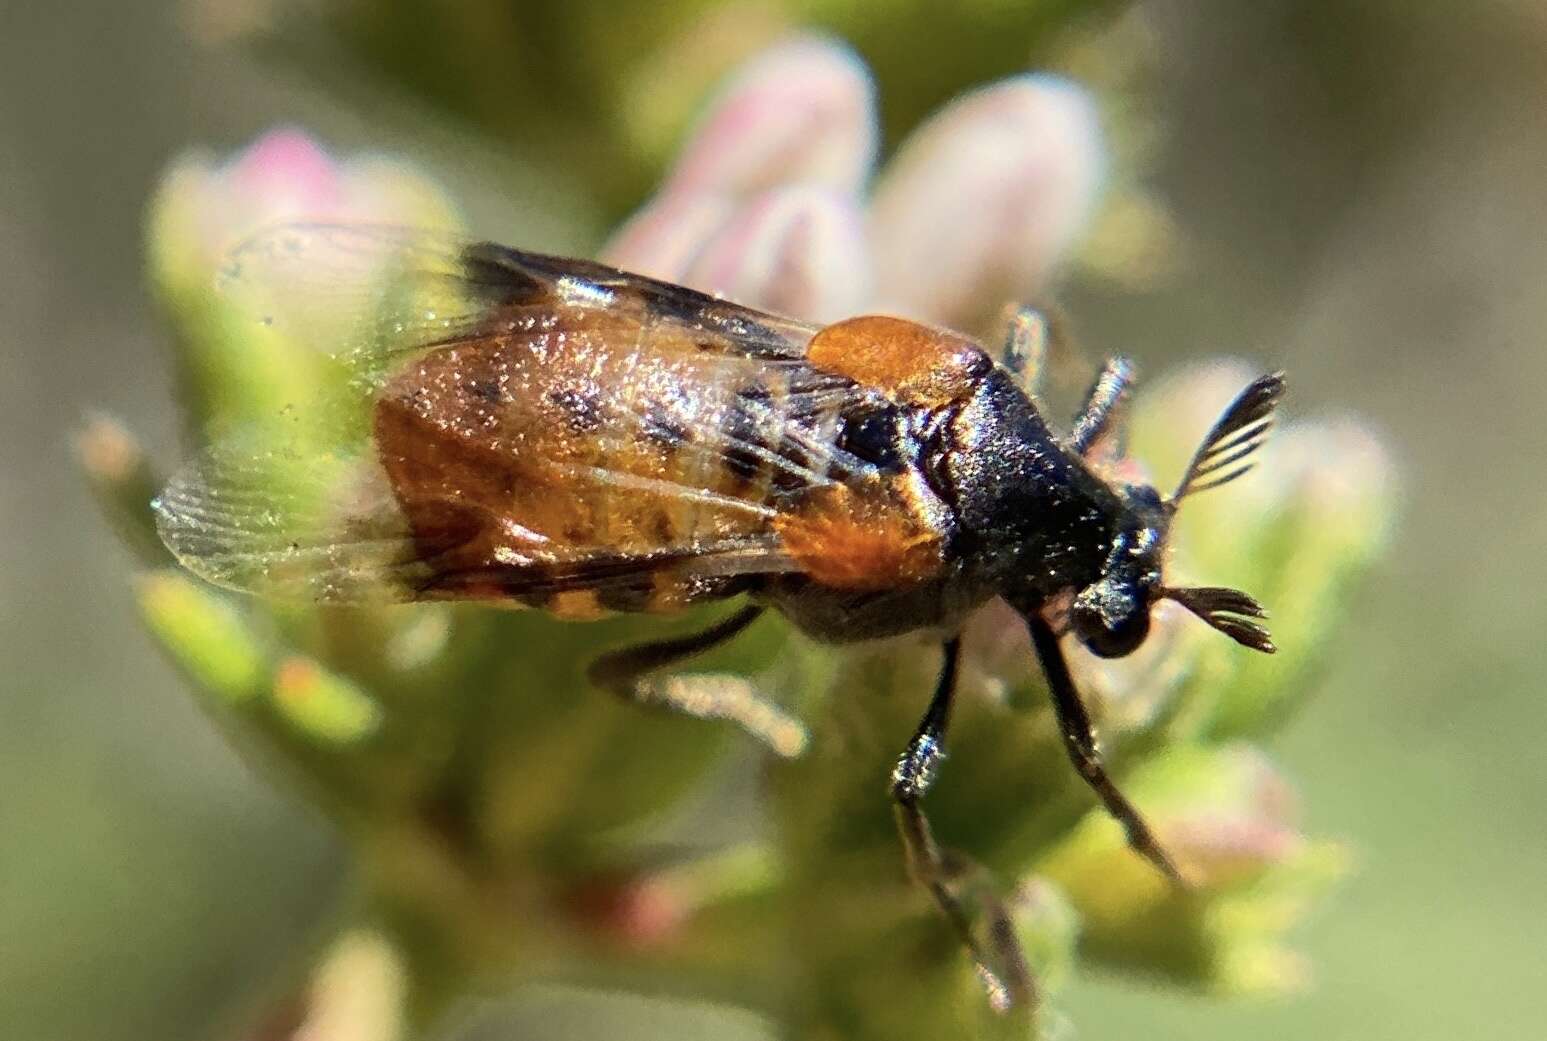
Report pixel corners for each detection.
[891,637,1036,1009]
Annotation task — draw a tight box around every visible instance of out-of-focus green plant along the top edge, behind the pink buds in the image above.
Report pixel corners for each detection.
[184,0,1122,212]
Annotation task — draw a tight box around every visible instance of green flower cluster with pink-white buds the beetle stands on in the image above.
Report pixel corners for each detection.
[82,40,1389,1041]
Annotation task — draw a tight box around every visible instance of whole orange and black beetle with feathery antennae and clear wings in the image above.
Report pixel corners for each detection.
[153,224,1284,995]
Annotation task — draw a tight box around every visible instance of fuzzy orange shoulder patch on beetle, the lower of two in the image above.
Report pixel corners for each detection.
[775,484,942,591]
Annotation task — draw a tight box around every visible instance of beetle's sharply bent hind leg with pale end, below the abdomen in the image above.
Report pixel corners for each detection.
[586,605,806,756]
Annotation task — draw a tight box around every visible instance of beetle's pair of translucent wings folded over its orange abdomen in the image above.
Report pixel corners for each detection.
[156,226,891,609]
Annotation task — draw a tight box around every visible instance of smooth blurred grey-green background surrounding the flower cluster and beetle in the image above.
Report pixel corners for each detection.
[0,0,1547,1041]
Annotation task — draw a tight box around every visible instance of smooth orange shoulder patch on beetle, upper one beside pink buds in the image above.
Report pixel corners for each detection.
[806,314,993,407]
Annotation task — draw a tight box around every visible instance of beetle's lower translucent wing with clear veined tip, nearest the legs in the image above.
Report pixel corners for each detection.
[155,430,789,609]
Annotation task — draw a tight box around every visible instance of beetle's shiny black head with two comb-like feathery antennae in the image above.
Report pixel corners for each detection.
[1069,373,1284,657]
